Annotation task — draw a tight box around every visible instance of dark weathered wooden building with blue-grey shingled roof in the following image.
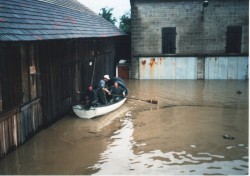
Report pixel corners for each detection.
[0,0,126,156]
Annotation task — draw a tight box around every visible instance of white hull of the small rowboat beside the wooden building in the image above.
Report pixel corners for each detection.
[72,98,127,119]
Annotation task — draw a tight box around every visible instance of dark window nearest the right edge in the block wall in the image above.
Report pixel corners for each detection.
[226,26,242,53]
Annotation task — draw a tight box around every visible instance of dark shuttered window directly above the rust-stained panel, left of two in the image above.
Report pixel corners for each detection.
[162,27,176,54]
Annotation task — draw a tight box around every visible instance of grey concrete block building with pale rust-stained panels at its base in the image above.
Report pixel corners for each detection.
[130,0,249,79]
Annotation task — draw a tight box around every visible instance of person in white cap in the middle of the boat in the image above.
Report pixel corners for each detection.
[97,75,110,105]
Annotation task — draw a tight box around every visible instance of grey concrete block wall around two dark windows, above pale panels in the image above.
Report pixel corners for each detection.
[131,0,249,79]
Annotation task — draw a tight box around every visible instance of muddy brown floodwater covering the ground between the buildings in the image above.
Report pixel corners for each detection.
[0,80,248,175]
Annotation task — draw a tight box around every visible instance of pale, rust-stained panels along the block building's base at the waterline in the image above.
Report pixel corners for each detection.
[138,57,248,79]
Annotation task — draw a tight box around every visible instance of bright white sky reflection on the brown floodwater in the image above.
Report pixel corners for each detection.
[88,109,248,175]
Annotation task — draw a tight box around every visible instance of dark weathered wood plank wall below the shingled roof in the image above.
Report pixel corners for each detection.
[0,38,121,158]
